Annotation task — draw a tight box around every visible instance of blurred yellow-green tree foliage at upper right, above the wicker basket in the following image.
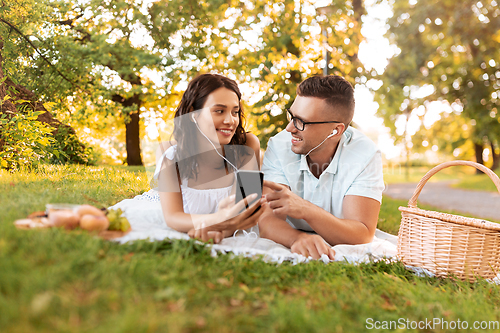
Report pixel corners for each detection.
[376,0,500,169]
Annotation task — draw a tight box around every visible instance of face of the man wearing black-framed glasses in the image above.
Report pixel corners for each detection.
[285,96,341,154]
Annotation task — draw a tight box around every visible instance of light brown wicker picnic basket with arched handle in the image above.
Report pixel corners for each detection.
[398,161,500,282]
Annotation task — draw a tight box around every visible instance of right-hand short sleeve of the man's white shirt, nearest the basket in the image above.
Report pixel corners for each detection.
[345,151,385,203]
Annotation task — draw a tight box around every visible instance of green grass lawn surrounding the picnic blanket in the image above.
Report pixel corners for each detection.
[0,166,500,332]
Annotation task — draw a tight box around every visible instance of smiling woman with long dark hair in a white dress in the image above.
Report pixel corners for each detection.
[155,74,262,243]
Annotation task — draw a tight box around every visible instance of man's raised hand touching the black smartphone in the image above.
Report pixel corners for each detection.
[262,180,310,219]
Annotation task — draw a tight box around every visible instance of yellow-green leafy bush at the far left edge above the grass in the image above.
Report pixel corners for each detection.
[0,105,55,170]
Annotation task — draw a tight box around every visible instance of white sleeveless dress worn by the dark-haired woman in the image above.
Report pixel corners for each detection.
[134,145,233,214]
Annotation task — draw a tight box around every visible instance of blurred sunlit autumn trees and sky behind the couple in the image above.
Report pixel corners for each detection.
[0,0,500,174]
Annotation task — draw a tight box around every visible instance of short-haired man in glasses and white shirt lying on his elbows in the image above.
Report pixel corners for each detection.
[259,75,384,259]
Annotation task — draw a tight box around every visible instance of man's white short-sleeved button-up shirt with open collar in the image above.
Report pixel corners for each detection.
[262,127,385,231]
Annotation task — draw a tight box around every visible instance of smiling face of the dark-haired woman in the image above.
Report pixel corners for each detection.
[195,87,240,145]
